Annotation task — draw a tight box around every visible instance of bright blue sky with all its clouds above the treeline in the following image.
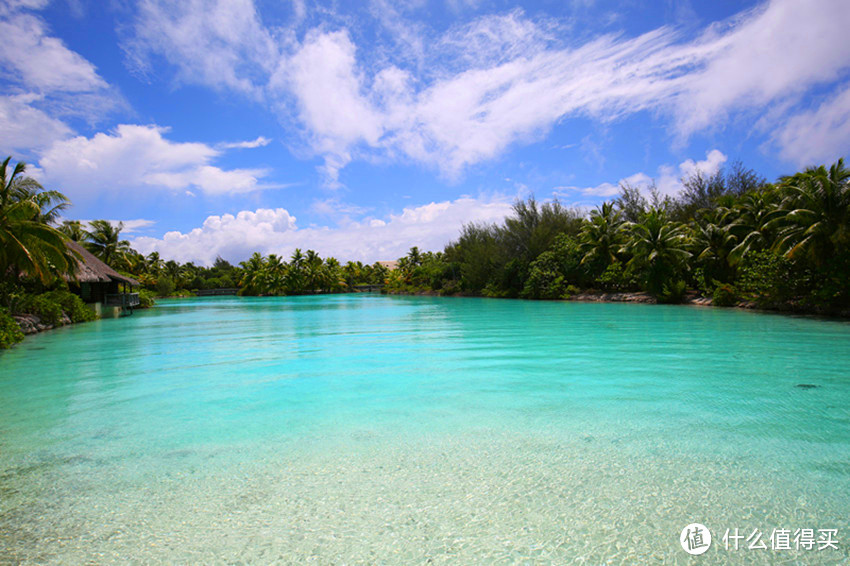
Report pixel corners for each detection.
[0,0,850,264]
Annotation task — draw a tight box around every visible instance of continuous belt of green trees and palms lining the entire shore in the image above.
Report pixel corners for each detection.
[0,157,850,348]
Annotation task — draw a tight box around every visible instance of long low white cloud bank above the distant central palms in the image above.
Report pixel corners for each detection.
[131,197,511,264]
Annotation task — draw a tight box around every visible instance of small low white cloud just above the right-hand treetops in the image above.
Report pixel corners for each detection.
[555,149,728,202]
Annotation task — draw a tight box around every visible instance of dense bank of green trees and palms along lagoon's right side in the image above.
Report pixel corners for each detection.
[389,160,850,312]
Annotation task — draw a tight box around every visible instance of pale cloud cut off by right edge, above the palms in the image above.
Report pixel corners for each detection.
[774,85,850,167]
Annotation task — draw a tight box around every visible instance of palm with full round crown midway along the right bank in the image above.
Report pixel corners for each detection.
[624,207,691,294]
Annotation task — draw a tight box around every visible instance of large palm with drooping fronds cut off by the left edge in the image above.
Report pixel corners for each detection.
[0,157,76,283]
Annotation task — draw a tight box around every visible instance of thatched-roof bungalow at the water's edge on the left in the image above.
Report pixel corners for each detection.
[66,241,139,318]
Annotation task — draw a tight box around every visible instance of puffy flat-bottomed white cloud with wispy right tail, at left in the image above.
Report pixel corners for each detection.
[39,124,277,194]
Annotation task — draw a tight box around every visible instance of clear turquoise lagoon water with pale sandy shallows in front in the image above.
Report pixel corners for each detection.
[0,295,850,564]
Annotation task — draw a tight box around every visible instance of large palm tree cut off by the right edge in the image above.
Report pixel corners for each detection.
[770,159,850,266]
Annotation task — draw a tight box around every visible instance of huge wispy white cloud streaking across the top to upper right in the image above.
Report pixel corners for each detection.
[121,0,850,178]
